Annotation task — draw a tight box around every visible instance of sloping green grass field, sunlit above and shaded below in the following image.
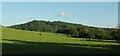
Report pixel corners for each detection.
[2,27,120,54]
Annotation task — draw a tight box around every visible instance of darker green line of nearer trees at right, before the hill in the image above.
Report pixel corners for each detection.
[57,27,120,41]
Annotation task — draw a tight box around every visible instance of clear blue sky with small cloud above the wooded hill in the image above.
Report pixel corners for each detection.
[2,2,118,28]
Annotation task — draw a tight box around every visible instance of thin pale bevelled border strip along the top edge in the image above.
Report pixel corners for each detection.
[1,0,119,2]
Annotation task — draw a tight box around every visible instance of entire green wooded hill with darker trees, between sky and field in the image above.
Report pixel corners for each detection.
[8,20,118,40]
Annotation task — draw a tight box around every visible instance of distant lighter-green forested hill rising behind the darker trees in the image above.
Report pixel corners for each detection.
[8,20,115,32]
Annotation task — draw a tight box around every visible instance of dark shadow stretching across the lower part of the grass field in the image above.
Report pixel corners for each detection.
[2,39,120,54]
